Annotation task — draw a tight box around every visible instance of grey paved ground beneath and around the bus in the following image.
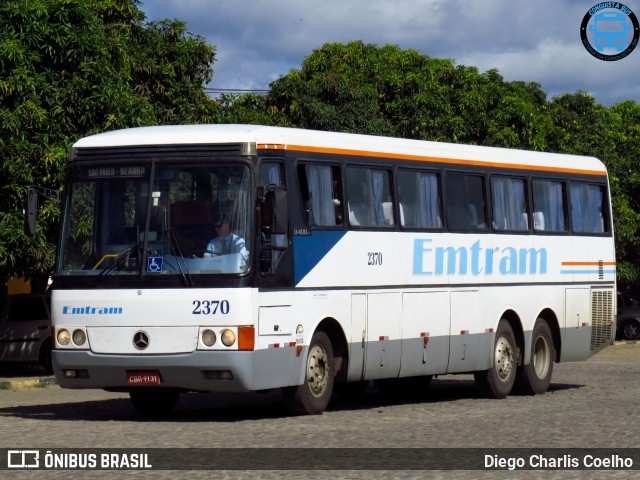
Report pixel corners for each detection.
[0,343,640,479]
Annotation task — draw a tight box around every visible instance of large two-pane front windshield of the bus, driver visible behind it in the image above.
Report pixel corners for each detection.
[57,161,251,276]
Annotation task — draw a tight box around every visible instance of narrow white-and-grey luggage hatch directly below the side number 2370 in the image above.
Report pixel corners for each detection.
[364,293,402,380]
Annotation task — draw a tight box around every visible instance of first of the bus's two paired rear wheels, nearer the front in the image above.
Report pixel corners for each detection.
[474,318,518,398]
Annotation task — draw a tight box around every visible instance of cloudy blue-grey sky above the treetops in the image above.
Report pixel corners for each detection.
[141,0,640,106]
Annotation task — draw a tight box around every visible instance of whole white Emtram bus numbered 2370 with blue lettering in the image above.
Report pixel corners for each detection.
[45,125,616,413]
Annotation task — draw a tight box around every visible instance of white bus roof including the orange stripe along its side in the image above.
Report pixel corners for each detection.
[74,125,606,175]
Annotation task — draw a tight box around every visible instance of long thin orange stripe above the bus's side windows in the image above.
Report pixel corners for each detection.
[257,144,607,176]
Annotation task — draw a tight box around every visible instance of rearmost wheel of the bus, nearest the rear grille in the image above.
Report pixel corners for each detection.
[516,318,556,395]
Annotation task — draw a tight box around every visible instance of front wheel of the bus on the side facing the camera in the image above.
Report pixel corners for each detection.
[283,331,335,415]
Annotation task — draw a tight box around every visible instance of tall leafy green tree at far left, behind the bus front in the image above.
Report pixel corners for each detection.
[0,0,219,290]
